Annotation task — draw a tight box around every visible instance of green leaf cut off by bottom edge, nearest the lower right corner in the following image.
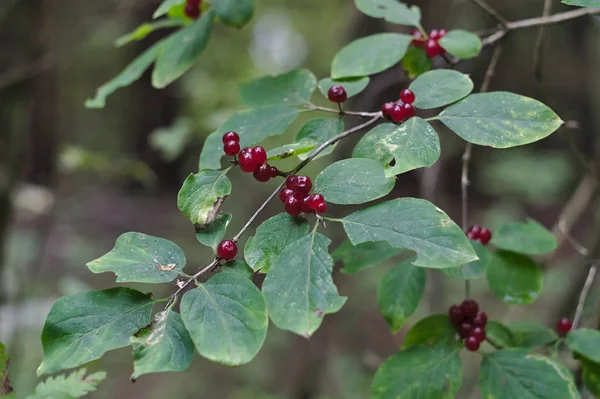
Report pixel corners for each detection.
[479,349,580,399]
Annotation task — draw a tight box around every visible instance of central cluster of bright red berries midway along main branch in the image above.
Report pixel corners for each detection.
[279,176,327,216]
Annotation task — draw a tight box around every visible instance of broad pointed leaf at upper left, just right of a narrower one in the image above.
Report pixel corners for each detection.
[152,9,215,89]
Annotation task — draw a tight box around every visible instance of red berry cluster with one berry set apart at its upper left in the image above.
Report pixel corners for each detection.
[222,132,279,182]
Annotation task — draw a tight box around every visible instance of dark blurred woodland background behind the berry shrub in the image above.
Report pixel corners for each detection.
[0,0,600,399]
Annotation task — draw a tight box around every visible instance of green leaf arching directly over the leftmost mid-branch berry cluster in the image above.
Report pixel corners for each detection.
[199,106,299,169]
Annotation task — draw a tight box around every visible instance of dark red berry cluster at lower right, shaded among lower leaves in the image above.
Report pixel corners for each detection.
[448,299,487,352]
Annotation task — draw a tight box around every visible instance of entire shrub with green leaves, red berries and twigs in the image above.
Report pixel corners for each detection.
[32,0,600,399]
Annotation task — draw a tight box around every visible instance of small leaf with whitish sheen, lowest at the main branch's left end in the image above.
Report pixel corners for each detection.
[131,310,194,381]
